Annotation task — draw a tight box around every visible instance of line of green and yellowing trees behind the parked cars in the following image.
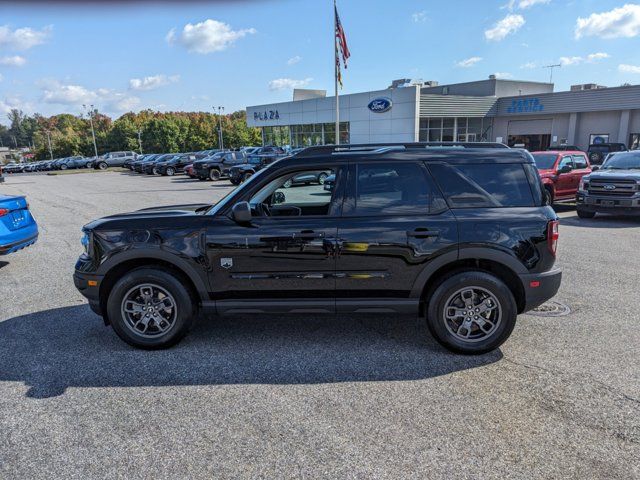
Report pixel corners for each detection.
[0,110,262,160]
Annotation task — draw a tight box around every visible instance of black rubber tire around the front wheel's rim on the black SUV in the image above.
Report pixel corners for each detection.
[107,267,197,350]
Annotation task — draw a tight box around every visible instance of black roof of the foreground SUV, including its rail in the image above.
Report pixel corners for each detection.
[279,142,534,165]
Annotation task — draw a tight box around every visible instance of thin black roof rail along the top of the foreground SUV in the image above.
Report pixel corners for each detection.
[293,142,509,158]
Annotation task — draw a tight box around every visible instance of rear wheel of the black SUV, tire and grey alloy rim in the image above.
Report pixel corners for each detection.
[427,271,517,354]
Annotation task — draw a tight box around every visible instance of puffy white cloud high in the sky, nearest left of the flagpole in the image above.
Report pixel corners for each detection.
[166,18,256,54]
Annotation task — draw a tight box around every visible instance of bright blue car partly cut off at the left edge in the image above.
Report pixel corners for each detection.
[0,195,38,255]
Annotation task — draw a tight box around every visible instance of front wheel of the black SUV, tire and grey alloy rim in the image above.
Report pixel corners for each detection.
[107,267,196,350]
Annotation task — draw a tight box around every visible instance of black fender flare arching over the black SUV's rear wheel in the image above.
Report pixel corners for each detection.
[411,247,530,298]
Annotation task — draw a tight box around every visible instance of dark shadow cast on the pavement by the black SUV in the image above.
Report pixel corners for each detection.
[0,305,502,398]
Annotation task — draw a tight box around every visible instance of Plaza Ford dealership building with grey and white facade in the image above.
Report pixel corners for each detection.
[247,76,640,150]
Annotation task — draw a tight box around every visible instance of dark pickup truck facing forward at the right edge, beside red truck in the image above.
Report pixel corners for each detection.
[576,150,640,218]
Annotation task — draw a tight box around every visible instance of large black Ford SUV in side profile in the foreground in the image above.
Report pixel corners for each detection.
[74,144,561,353]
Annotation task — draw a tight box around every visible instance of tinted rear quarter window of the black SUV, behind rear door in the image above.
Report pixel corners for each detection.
[429,163,535,208]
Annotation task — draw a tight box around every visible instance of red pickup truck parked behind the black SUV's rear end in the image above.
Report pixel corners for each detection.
[531,150,591,203]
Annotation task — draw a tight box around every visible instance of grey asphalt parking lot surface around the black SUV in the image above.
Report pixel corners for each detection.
[0,172,640,479]
